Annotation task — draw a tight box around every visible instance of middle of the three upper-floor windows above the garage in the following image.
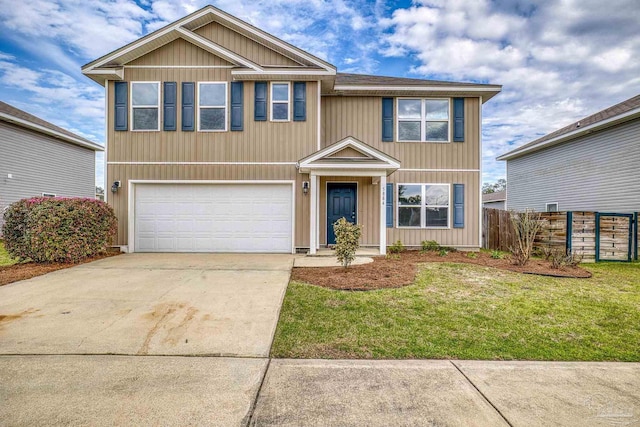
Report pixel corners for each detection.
[198,82,227,131]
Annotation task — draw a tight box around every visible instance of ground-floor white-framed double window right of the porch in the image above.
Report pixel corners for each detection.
[398,184,450,228]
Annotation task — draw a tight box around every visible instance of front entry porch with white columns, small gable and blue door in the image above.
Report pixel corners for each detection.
[298,137,400,255]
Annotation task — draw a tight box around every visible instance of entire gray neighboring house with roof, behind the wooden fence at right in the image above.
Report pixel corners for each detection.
[498,95,640,213]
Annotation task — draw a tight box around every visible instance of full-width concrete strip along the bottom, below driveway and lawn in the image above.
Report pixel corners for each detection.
[0,355,640,427]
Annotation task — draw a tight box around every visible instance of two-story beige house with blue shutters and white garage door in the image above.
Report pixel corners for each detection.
[82,6,501,254]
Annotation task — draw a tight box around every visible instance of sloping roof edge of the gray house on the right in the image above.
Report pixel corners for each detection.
[498,95,640,160]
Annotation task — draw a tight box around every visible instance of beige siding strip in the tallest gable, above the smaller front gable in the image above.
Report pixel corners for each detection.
[195,22,300,67]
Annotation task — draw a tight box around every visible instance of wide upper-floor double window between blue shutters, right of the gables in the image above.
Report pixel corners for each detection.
[397,98,451,142]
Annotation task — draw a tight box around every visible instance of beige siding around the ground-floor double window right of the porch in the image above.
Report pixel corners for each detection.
[387,171,481,248]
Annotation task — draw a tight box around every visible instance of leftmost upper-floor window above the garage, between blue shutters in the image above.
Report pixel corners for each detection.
[131,82,160,130]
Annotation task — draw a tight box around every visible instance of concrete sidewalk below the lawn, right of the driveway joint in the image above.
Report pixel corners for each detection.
[251,360,640,427]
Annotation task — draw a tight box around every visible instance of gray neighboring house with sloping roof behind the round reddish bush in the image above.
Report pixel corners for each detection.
[0,101,103,231]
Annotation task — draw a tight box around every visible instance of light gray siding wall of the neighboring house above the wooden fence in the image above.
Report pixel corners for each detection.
[507,119,640,213]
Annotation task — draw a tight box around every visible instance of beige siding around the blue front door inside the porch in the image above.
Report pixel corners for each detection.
[318,176,380,246]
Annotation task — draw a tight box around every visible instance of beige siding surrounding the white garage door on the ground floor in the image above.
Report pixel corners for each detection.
[107,165,310,248]
